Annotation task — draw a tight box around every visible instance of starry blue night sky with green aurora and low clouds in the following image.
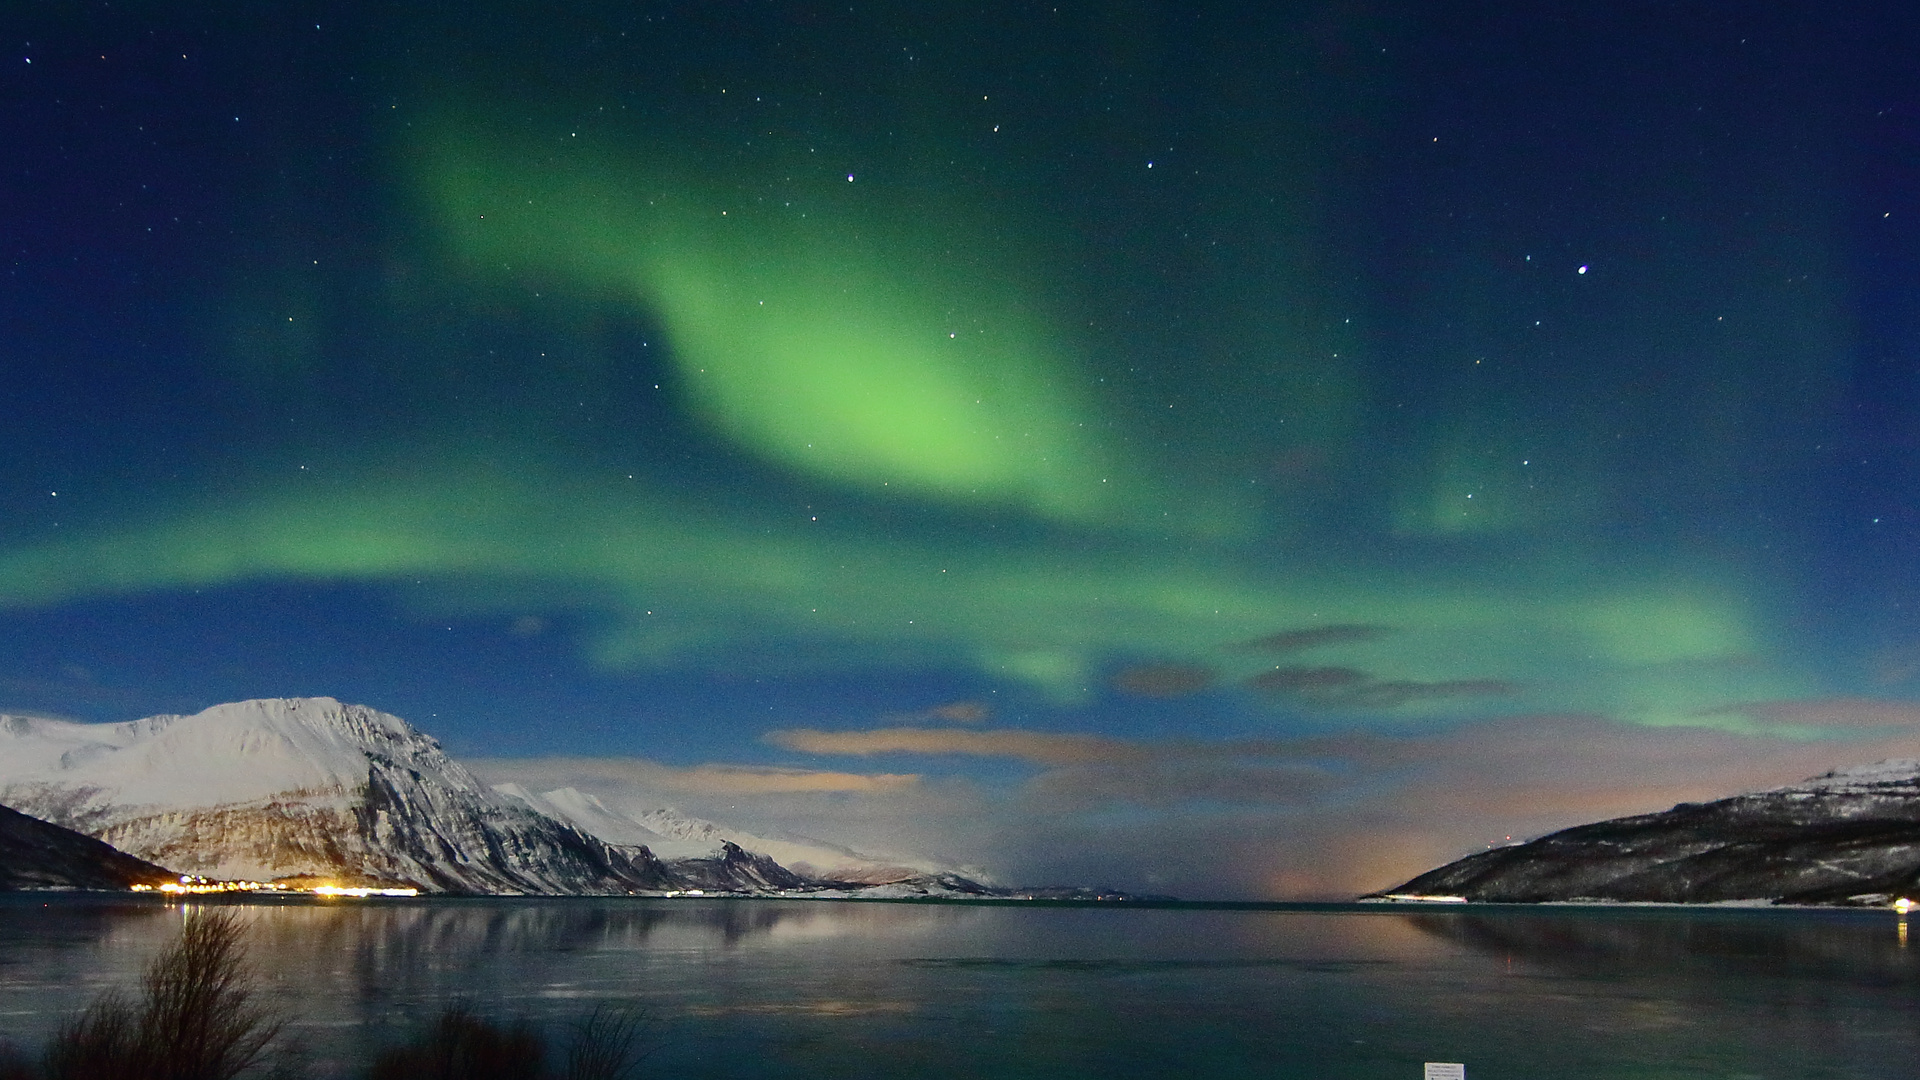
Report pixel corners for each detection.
[0,0,1920,897]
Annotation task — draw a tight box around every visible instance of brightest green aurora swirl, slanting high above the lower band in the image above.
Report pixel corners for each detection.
[422,124,1139,521]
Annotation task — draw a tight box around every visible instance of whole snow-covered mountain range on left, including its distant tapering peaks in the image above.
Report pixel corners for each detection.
[0,698,1082,899]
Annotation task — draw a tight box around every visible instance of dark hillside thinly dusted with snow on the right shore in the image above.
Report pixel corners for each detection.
[1377,761,1920,905]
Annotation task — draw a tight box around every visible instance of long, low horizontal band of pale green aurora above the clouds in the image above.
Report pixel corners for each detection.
[0,438,1797,726]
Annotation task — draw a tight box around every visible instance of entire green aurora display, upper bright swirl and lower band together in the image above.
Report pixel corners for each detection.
[0,84,1835,728]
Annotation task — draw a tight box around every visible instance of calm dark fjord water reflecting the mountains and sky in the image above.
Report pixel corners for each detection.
[0,896,1920,1080]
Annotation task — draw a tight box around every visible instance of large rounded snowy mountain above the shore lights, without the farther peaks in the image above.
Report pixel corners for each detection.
[0,698,680,894]
